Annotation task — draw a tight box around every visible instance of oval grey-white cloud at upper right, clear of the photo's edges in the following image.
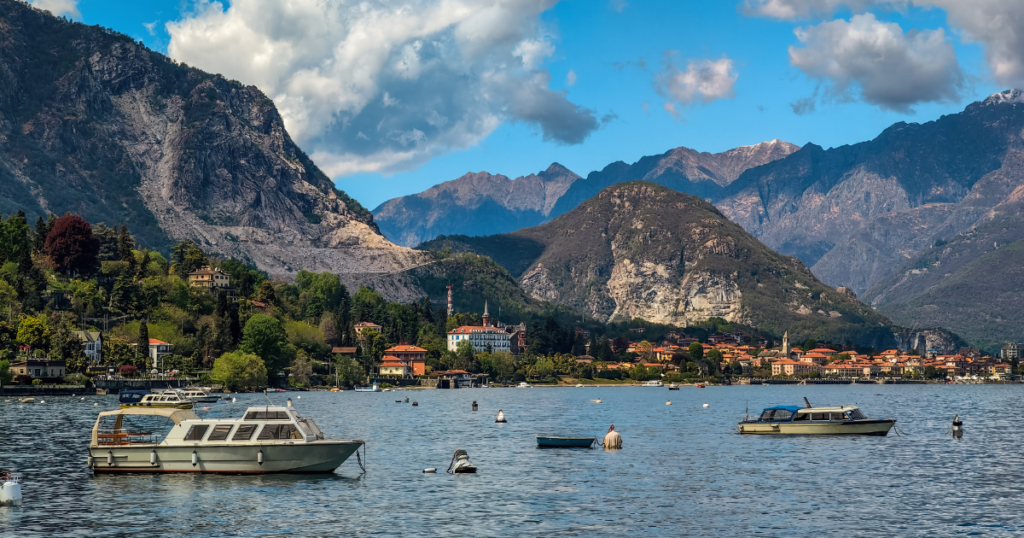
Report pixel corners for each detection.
[790,13,965,112]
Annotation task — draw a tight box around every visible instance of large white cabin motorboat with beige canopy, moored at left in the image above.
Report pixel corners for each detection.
[88,402,364,474]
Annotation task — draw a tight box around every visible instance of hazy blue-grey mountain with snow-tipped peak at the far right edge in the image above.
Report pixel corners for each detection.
[716,90,1024,297]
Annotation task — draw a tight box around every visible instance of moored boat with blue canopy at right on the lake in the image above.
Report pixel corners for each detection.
[739,406,896,436]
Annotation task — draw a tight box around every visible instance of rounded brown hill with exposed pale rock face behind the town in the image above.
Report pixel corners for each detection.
[421,181,894,345]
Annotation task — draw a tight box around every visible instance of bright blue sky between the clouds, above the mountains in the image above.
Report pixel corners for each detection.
[54,0,1006,208]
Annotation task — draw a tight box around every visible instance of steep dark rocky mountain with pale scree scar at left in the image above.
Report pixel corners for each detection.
[0,0,432,298]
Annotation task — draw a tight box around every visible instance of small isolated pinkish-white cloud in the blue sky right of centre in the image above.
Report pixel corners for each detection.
[654,52,737,113]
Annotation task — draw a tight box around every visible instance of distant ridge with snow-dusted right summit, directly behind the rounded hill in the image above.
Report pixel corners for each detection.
[551,138,800,216]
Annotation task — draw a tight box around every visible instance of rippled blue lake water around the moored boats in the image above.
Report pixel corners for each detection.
[0,385,1024,537]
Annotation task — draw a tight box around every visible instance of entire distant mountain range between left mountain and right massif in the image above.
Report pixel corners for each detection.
[373,139,799,247]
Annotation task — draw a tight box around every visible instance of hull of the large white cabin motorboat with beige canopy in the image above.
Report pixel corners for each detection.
[89,440,362,474]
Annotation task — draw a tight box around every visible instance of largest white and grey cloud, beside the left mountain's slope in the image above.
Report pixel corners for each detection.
[167,0,600,175]
